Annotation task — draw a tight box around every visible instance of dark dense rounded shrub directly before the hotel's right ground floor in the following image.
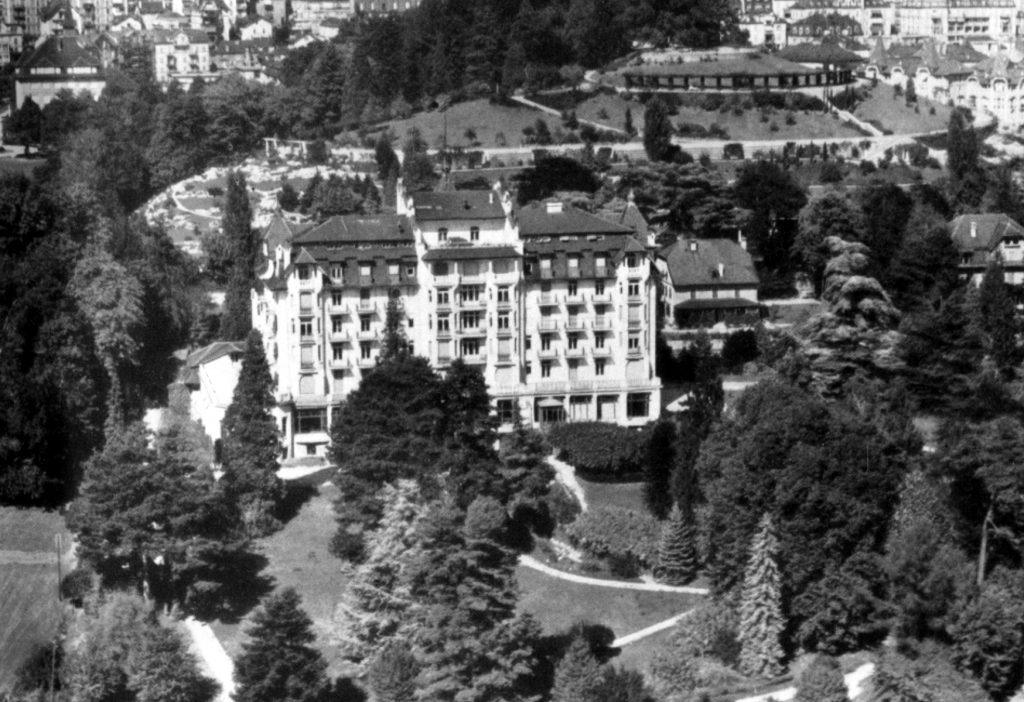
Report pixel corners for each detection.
[548,422,647,480]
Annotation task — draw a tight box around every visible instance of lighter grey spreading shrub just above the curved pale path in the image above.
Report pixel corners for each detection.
[565,507,662,568]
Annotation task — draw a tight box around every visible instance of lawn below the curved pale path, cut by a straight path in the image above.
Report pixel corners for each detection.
[516,567,701,669]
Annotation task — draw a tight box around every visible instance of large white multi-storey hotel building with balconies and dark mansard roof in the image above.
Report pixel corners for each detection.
[253,188,662,457]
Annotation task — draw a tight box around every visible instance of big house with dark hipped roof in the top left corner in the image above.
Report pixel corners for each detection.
[14,35,106,107]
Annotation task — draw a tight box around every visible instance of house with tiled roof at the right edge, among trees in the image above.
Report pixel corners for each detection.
[949,214,1024,286]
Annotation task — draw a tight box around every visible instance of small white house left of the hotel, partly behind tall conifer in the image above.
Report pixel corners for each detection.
[178,341,246,445]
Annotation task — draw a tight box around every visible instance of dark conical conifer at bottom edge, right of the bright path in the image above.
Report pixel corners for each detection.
[234,587,330,702]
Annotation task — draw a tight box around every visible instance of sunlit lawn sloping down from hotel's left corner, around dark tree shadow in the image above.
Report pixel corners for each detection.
[205,485,354,675]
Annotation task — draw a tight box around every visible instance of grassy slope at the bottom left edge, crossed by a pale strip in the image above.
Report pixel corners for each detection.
[0,508,71,691]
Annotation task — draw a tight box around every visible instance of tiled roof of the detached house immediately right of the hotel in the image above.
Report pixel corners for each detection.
[657,238,759,289]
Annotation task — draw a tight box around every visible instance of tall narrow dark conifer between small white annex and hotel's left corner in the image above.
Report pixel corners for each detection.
[223,331,282,535]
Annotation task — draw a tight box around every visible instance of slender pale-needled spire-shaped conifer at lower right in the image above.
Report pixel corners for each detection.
[738,514,785,677]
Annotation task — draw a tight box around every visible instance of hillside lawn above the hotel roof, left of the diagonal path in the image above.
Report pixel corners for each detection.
[360,99,561,148]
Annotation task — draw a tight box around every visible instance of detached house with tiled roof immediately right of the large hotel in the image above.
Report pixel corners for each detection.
[655,238,762,328]
